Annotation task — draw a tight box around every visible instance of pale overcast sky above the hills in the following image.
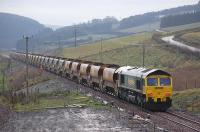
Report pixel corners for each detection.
[0,0,199,26]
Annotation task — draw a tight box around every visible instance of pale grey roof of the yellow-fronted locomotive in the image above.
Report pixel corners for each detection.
[116,66,171,78]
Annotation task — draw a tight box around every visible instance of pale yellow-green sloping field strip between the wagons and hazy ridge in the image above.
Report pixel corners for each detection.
[56,33,151,58]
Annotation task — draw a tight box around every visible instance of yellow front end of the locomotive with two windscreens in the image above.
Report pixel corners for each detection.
[143,73,173,111]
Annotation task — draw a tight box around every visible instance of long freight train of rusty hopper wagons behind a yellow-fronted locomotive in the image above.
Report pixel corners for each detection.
[10,52,173,111]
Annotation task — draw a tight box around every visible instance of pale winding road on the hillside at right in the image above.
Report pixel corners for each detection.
[162,36,200,54]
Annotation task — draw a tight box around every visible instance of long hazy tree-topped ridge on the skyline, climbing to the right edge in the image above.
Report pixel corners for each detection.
[11,3,200,51]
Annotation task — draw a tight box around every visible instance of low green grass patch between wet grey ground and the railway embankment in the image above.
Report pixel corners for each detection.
[14,91,108,112]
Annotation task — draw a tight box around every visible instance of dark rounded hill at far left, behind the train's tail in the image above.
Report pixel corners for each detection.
[0,13,45,48]
